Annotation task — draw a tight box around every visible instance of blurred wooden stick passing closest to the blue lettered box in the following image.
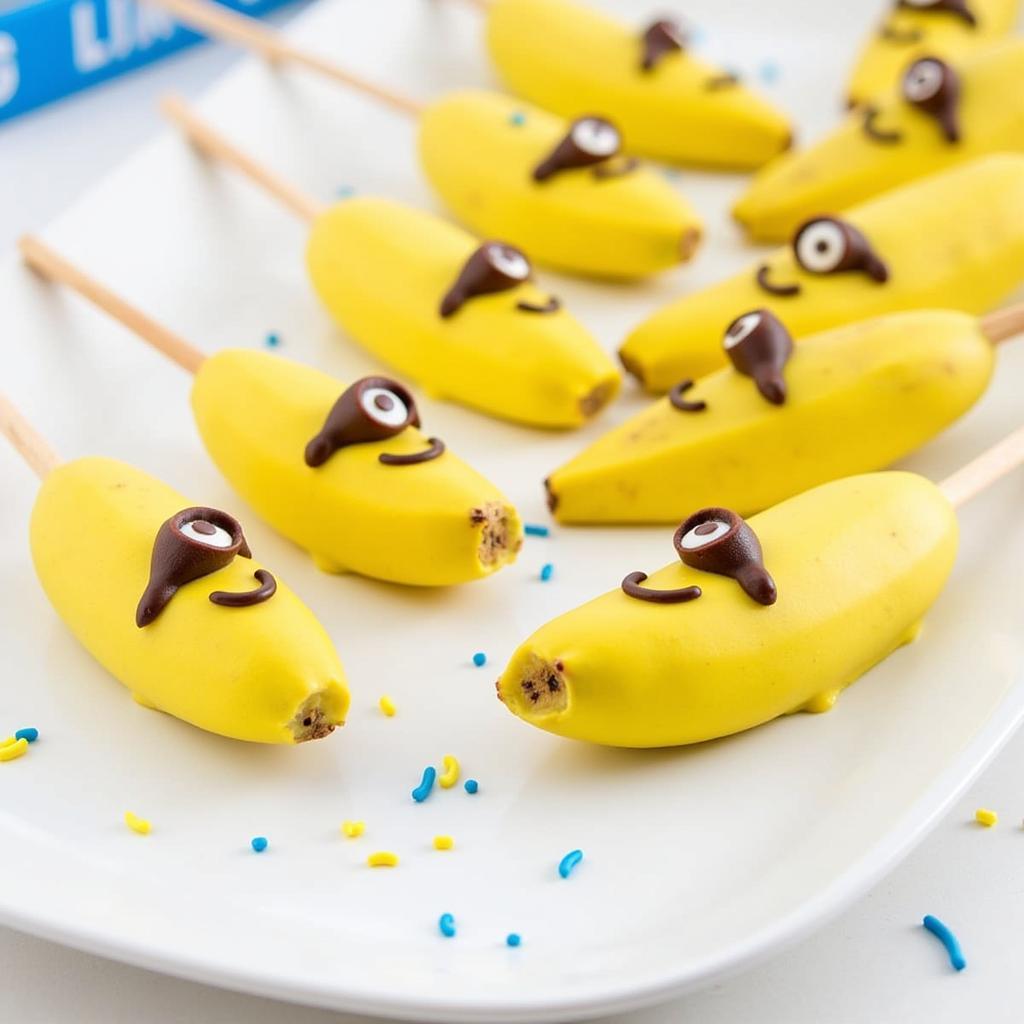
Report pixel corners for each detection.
[147,0,424,117]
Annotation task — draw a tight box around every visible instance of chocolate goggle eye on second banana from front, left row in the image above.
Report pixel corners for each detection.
[305,377,428,468]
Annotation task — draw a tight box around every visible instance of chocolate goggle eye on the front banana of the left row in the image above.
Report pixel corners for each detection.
[135,506,252,629]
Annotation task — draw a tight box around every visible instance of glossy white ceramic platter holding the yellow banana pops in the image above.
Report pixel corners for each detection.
[0,0,1024,1021]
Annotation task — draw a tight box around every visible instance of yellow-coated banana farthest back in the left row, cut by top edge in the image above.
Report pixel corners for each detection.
[486,0,793,170]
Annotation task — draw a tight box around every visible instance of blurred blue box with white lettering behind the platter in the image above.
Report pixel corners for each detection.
[0,0,288,122]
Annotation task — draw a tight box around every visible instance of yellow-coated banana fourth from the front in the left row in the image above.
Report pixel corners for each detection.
[419,91,701,280]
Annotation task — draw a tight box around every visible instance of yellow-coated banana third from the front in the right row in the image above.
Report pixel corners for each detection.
[620,155,1024,392]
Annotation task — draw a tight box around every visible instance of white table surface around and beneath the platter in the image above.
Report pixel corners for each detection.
[0,3,1024,1024]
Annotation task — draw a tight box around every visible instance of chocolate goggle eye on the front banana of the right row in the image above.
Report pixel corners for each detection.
[672,508,778,605]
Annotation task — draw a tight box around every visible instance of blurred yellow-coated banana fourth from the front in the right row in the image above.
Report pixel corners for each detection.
[733,38,1024,242]
